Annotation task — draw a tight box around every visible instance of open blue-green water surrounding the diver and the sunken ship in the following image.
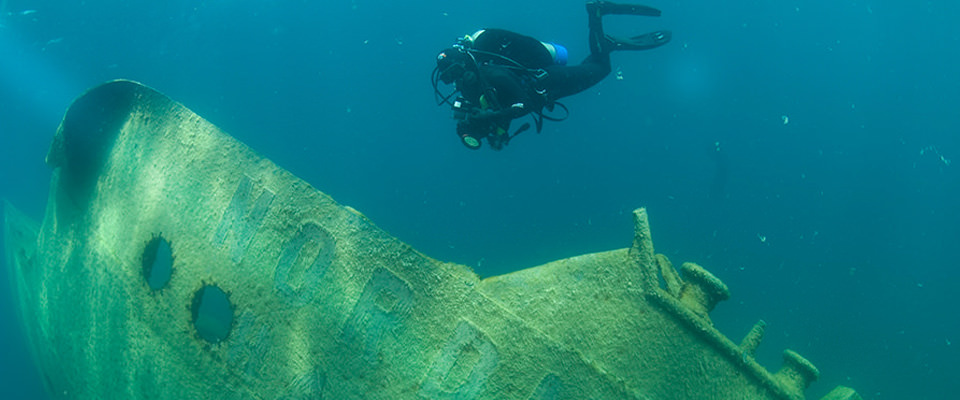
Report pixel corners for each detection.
[0,0,960,399]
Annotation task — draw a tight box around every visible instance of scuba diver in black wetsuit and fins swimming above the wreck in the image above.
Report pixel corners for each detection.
[432,1,671,150]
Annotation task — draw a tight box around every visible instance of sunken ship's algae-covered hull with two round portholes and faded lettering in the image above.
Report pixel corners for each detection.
[4,81,859,400]
